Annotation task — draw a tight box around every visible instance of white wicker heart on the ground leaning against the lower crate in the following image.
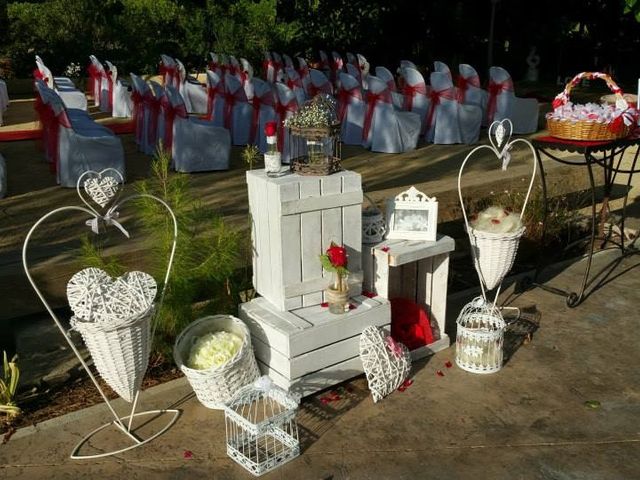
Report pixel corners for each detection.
[360,326,411,403]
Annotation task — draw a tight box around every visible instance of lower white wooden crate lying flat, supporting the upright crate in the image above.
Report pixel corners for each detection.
[239,296,391,395]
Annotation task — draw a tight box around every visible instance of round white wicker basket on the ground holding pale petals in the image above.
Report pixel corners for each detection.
[173,315,260,410]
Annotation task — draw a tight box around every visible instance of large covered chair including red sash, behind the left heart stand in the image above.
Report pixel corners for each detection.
[35,79,125,187]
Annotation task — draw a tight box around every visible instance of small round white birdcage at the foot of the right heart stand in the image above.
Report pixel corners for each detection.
[456,297,506,373]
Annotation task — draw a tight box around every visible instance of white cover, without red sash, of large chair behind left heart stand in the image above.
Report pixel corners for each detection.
[36,82,125,188]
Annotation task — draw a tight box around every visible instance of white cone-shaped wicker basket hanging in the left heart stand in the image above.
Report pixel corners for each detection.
[71,306,155,402]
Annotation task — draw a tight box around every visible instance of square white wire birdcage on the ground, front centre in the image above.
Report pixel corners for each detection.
[225,376,300,476]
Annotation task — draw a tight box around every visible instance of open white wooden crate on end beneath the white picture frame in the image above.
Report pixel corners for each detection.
[363,235,455,360]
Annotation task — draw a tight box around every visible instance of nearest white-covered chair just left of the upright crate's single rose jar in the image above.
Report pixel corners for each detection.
[165,87,231,172]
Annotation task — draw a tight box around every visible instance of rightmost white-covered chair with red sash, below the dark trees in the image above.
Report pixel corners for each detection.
[487,67,539,134]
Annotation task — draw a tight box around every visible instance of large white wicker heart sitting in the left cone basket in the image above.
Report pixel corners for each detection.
[67,268,158,326]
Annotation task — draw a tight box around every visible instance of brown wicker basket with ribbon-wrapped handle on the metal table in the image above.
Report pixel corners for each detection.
[547,72,631,141]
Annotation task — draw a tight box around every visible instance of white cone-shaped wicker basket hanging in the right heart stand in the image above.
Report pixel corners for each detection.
[468,227,525,290]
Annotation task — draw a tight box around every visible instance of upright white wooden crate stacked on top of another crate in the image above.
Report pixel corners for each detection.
[247,170,362,310]
